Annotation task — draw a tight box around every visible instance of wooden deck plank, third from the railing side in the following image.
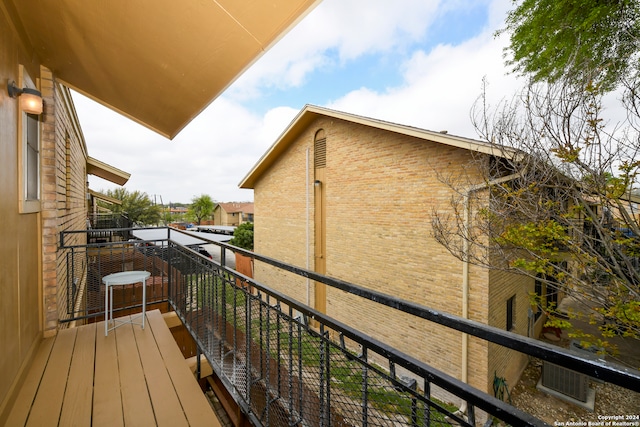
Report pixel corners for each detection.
[115,325,155,426]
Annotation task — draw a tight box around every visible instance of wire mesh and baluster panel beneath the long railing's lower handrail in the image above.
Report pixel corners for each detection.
[170,244,470,426]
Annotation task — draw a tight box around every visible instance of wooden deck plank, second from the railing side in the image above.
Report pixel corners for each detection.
[133,314,189,427]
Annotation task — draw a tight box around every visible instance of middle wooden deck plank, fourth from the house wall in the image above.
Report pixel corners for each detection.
[93,321,124,427]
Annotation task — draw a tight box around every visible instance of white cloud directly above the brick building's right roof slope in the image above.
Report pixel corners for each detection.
[330,1,520,137]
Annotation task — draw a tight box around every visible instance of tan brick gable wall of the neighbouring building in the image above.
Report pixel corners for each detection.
[254,117,528,391]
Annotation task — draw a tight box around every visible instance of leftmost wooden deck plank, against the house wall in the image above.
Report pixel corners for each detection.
[6,337,55,426]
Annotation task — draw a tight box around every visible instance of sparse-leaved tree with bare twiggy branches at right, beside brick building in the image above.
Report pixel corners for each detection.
[432,79,640,347]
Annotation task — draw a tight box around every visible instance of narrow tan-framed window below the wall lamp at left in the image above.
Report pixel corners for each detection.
[18,67,40,213]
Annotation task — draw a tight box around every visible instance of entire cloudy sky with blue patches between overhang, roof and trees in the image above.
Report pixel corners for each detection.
[74,0,520,204]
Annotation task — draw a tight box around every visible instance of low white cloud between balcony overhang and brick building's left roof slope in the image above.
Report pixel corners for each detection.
[79,90,297,203]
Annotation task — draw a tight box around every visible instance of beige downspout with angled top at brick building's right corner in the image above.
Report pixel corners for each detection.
[460,173,522,398]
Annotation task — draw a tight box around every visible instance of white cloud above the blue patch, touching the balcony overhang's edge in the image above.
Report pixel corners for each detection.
[229,0,439,100]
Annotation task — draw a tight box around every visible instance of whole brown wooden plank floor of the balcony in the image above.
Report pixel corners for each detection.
[7,310,220,427]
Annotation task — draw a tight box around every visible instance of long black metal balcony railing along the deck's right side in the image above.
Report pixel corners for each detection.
[61,229,640,426]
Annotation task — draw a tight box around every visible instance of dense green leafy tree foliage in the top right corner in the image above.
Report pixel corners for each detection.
[502,0,640,90]
